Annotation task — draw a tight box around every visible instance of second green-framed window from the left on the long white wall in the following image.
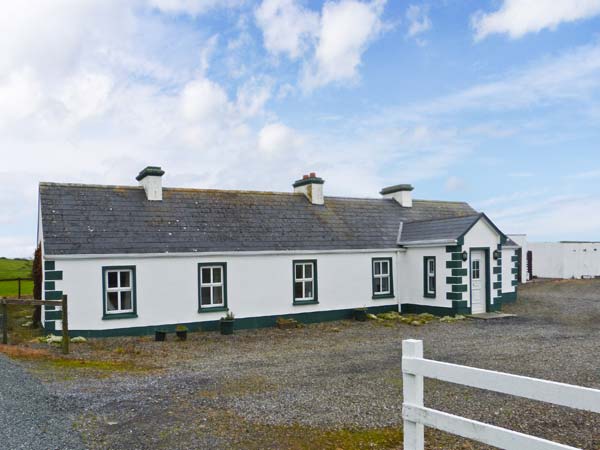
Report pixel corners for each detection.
[198,263,227,312]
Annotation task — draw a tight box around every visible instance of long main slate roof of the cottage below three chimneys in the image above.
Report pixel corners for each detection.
[40,183,476,255]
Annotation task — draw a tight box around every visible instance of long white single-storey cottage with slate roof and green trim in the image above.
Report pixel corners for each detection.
[38,167,518,336]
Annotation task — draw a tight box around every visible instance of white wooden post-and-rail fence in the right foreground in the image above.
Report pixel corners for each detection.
[402,340,600,450]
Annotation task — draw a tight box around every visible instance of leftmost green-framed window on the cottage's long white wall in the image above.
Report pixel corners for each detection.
[102,266,137,319]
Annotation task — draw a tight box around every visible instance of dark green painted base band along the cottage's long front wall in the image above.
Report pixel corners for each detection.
[63,303,398,337]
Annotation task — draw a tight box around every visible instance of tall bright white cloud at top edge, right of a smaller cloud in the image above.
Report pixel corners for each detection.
[303,0,386,89]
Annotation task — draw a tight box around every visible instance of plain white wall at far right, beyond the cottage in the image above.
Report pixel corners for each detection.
[529,242,600,279]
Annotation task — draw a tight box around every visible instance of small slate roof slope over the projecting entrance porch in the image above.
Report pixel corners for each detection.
[398,214,482,245]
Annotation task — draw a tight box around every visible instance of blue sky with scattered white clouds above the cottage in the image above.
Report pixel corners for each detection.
[0,0,600,257]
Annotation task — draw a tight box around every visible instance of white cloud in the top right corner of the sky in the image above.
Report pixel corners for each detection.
[471,0,600,40]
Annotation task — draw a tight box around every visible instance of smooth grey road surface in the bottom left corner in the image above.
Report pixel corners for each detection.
[0,356,84,450]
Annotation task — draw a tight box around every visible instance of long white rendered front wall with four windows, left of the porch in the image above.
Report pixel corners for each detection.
[45,252,398,330]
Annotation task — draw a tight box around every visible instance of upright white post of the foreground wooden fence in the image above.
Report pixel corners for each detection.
[402,339,425,450]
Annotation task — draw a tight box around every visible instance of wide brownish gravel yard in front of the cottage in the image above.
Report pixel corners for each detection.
[8,280,600,450]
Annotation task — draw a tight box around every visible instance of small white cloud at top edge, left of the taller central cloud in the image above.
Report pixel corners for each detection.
[255,0,319,59]
